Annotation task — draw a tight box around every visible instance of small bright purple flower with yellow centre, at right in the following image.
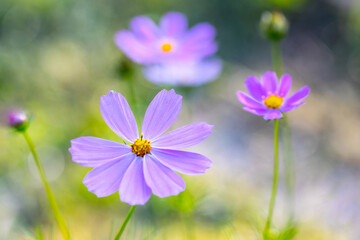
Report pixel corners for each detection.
[237,72,310,120]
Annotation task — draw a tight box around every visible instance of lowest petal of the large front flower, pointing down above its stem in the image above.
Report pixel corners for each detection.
[119,157,151,205]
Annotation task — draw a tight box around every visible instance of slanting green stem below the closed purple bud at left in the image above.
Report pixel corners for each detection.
[23,130,70,240]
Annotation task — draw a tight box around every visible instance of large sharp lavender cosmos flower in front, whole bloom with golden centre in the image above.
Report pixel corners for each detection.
[69,89,213,205]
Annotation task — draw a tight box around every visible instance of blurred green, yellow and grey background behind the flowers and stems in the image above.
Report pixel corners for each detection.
[0,0,360,240]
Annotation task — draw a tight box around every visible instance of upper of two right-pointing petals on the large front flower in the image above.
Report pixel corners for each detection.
[151,122,214,149]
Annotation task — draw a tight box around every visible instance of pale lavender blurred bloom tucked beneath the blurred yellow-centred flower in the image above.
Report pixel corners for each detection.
[143,59,222,86]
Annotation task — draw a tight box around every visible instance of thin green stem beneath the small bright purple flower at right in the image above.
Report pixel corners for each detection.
[263,119,279,239]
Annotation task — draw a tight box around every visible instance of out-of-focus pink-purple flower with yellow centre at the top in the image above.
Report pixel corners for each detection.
[115,12,217,64]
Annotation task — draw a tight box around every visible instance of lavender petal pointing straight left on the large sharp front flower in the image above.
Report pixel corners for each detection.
[69,137,131,167]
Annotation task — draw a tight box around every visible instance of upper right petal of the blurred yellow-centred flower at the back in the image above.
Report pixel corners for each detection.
[182,23,217,58]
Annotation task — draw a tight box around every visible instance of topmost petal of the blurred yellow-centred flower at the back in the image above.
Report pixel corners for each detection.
[160,12,187,36]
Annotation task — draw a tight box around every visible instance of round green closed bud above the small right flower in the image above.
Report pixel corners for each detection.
[260,11,289,41]
